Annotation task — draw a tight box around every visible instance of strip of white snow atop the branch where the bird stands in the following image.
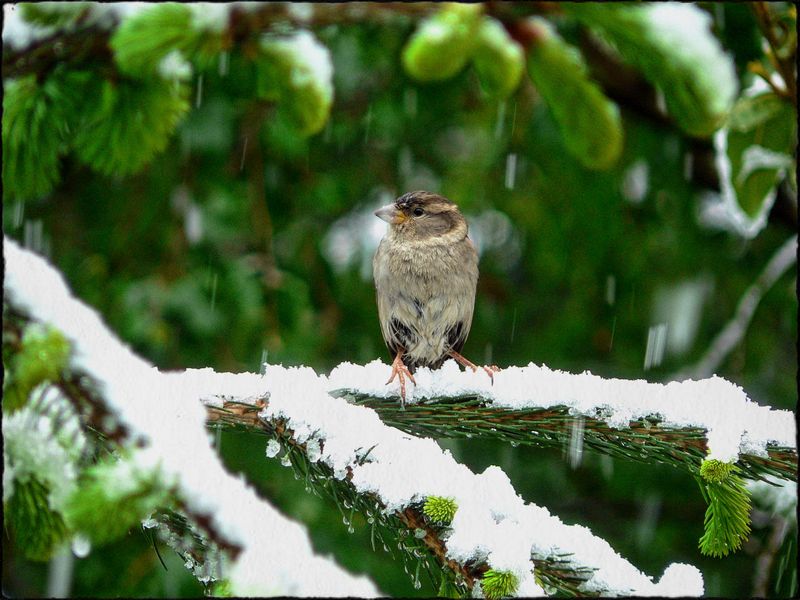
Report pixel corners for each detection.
[329,360,795,462]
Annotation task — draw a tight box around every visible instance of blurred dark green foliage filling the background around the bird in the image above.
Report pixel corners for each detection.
[3,4,797,596]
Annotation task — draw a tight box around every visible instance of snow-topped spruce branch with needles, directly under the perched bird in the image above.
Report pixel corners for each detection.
[329,361,797,479]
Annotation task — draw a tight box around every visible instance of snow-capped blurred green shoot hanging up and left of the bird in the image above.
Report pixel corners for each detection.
[256,31,333,136]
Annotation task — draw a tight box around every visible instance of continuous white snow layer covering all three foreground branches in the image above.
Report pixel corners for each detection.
[9,239,794,596]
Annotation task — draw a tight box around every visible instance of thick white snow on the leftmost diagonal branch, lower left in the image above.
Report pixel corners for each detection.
[3,237,379,597]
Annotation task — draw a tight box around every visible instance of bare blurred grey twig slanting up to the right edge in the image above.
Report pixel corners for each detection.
[670,235,797,380]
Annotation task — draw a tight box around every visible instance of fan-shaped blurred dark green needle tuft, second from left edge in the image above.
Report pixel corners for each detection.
[72,78,189,176]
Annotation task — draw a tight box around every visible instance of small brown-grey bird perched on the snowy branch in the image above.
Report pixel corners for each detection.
[372,191,499,403]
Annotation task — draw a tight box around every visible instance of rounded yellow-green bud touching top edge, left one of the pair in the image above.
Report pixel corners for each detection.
[403,3,482,81]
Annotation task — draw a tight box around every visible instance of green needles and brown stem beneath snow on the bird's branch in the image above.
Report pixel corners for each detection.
[334,390,797,479]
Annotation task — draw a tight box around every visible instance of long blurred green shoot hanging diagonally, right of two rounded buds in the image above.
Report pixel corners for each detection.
[528,18,623,170]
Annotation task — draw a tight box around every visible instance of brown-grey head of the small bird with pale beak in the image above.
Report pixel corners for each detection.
[375,191,467,242]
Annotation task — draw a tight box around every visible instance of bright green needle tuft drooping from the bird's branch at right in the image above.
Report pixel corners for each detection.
[698,461,750,558]
